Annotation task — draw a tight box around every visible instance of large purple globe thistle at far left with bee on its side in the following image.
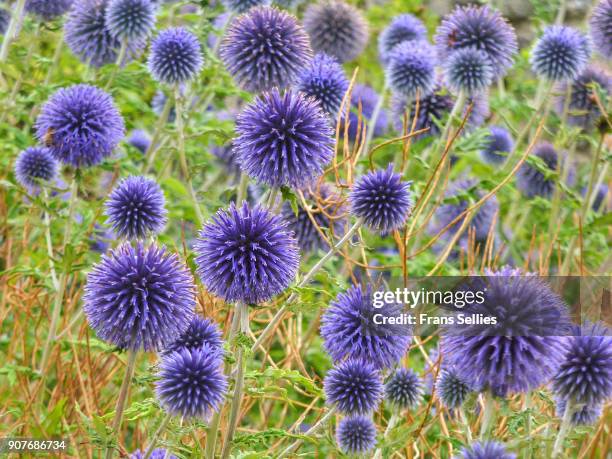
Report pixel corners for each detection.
[35,84,125,167]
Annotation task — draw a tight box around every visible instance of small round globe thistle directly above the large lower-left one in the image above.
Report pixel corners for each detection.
[105,176,167,239]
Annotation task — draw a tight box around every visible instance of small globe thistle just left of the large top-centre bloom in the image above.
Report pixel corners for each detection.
[148,27,204,85]
